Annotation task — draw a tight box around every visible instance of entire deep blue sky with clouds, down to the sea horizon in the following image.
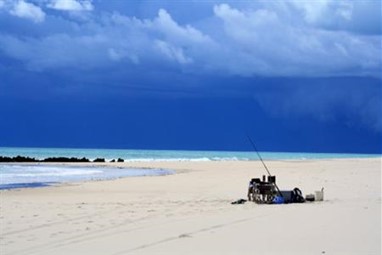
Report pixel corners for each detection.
[0,0,382,153]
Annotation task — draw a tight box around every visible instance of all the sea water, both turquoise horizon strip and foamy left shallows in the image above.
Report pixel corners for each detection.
[0,147,381,189]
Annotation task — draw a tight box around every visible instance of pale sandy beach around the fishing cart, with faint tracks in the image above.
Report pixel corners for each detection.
[0,158,381,255]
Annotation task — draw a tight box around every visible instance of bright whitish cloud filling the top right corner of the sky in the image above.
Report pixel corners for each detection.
[270,0,382,34]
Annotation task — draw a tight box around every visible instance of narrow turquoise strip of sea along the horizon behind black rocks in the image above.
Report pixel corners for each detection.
[0,147,381,161]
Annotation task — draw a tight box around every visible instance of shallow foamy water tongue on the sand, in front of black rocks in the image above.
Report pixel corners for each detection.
[0,162,175,190]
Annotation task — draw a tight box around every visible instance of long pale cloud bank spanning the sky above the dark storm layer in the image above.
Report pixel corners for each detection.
[0,3,382,77]
